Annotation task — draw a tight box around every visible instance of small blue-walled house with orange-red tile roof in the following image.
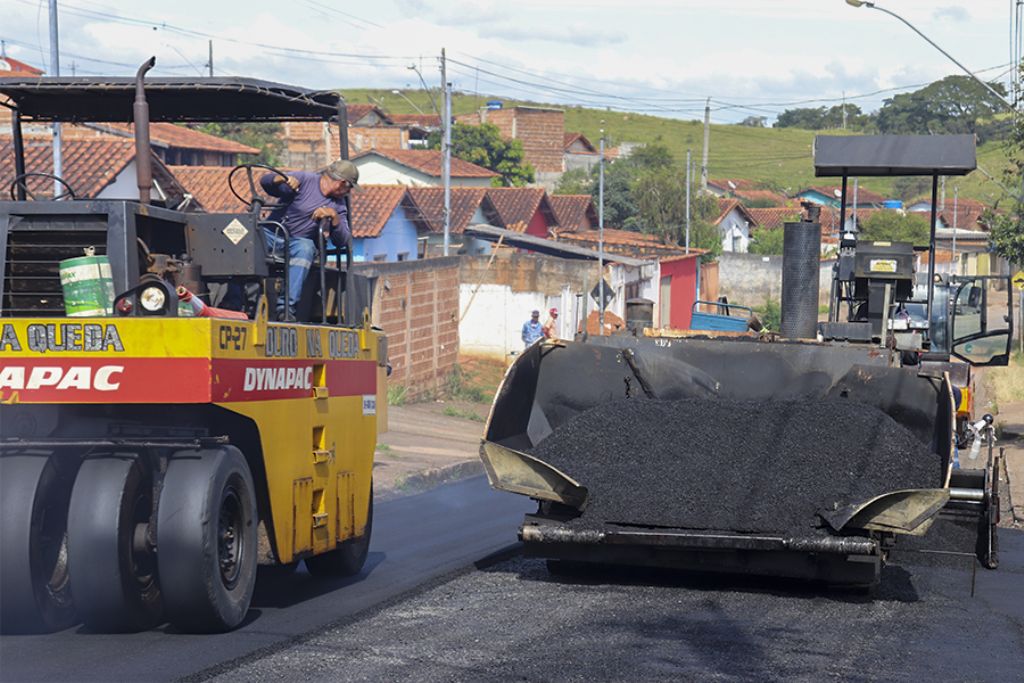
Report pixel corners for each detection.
[351,185,429,263]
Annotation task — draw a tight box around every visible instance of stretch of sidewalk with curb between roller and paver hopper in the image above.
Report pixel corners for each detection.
[374,401,489,501]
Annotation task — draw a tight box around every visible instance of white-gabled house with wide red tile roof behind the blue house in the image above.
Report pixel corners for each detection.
[352,150,500,187]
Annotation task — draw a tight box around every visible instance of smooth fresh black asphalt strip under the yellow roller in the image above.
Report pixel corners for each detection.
[0,476,535,681]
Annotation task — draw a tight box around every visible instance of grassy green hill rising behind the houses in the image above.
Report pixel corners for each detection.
[342,89,1008,204]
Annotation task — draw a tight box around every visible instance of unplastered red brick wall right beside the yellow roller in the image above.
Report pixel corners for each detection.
[357,256,459,400]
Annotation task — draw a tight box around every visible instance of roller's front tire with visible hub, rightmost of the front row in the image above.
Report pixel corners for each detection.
[157,445,258,633]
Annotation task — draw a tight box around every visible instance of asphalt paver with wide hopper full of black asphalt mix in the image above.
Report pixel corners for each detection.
[480,136,1012,587]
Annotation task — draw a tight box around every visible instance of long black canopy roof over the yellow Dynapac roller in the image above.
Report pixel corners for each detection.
[0,78,343,123]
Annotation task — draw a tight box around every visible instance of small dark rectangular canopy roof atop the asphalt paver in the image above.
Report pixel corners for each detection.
[814,135,978,177]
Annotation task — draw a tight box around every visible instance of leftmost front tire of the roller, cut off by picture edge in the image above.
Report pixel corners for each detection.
[0,455,78,634]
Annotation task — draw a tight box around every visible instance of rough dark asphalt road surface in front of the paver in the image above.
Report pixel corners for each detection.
[213,529,1024,683]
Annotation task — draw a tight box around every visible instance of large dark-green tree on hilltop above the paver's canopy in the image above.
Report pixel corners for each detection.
[876,76,1006,135]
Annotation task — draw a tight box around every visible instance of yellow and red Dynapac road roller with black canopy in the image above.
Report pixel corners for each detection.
[0,60,387,633]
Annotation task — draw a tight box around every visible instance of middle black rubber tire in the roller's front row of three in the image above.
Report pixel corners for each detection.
[68,456,163,633]
